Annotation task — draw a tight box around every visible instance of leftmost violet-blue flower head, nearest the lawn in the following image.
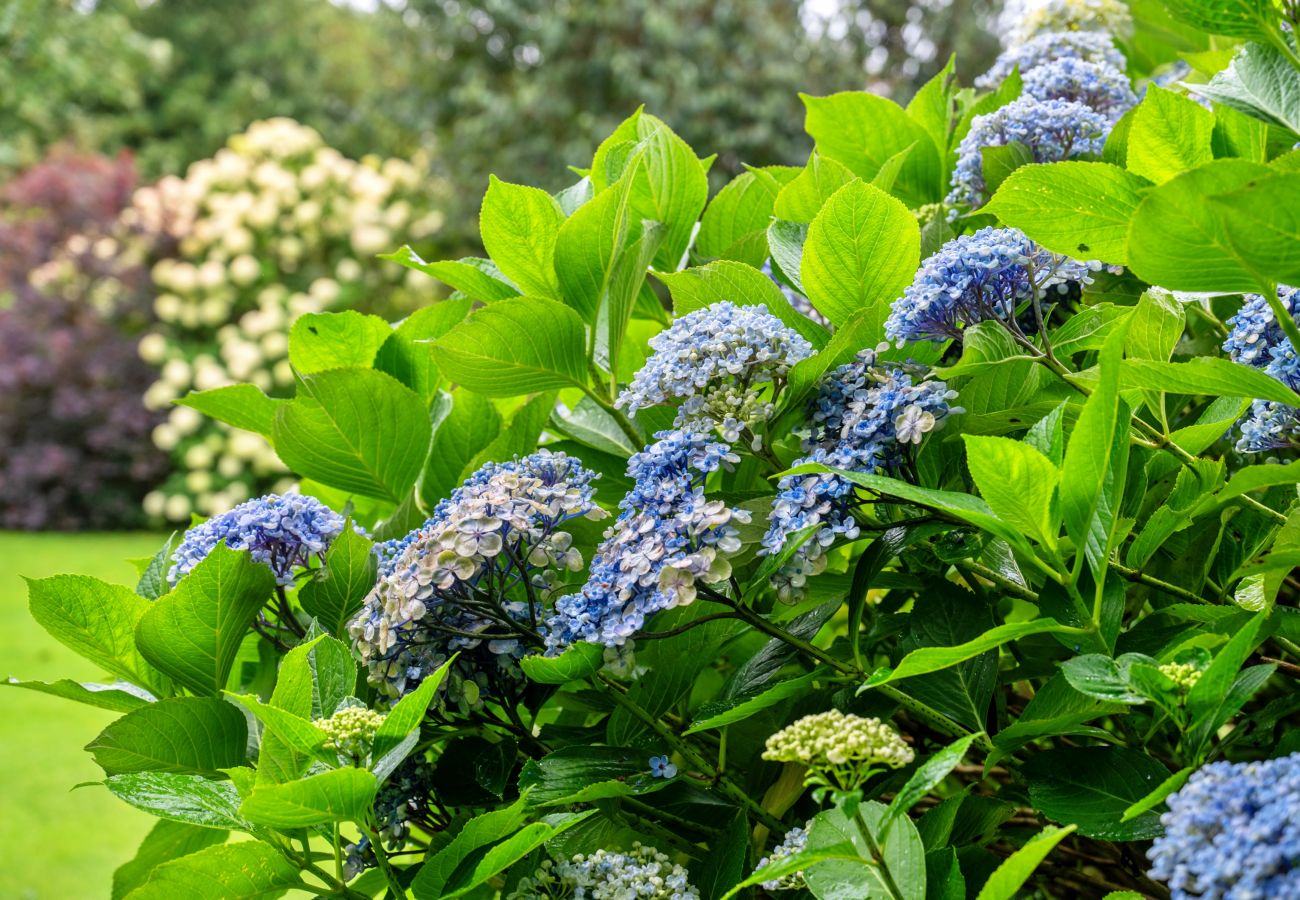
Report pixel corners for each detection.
[168,494,345,587]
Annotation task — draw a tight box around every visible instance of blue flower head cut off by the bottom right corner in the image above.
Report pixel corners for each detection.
[1147,753,1300,900]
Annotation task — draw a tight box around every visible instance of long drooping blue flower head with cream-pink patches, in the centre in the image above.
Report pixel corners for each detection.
[546,430,750,654]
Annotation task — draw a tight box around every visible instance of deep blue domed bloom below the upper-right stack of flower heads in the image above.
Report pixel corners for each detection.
[885,226,1101,346]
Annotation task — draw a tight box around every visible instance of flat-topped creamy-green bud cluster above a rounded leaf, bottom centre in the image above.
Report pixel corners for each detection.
[763,709,915,791]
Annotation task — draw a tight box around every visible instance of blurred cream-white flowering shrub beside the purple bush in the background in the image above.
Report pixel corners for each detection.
[134,118,442,522]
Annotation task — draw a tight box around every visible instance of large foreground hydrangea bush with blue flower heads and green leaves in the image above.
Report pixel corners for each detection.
[16,0,1300,900]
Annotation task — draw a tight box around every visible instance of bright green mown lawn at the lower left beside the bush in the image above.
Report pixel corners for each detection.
[0,532,163,900]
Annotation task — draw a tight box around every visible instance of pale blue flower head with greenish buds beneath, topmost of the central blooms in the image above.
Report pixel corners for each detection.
[618,300,813,442]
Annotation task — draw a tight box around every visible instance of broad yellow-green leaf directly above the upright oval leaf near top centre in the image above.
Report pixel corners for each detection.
[795,91,944,206]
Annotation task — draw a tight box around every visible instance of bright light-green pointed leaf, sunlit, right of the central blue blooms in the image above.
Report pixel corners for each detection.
[963,434,1061,548]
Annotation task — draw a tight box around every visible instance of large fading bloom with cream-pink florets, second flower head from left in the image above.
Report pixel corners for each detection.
[348,450,606,709]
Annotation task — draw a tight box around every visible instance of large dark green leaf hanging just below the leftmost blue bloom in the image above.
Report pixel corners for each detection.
[135,541,276,696]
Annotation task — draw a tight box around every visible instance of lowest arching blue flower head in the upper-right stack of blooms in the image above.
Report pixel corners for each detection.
[948,96,1110,208]
